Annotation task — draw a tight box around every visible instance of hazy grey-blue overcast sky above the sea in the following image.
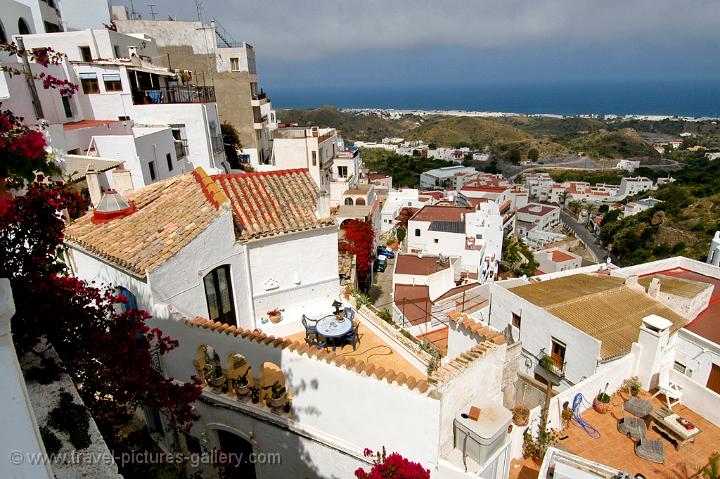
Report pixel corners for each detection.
[118,0,720,88]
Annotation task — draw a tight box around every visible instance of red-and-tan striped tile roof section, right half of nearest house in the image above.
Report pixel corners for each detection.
[213,168,333,240]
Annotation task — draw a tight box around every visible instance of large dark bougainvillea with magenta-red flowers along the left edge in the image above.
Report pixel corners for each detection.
[0,45,201,454]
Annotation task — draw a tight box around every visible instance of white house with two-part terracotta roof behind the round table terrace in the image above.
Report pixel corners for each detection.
[66,168,339,338]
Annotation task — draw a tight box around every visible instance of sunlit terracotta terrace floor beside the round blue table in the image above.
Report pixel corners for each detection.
[288,322,427,381]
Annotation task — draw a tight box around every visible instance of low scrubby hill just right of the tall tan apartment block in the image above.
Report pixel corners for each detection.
[277,106,416,141]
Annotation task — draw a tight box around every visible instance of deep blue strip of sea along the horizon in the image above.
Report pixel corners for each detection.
[267,81,720,117]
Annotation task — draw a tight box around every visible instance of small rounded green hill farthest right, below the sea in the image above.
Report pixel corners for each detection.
[565,128,660,159]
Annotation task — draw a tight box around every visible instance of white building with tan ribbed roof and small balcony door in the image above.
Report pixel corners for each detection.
[490,274,686,390]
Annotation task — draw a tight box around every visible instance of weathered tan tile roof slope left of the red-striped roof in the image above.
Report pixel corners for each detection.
[65,168,224,276]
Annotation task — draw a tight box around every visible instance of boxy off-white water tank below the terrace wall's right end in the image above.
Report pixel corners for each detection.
[454,403,512,465]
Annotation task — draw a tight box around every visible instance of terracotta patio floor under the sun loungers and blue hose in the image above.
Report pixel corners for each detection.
[510,393,720,479]
